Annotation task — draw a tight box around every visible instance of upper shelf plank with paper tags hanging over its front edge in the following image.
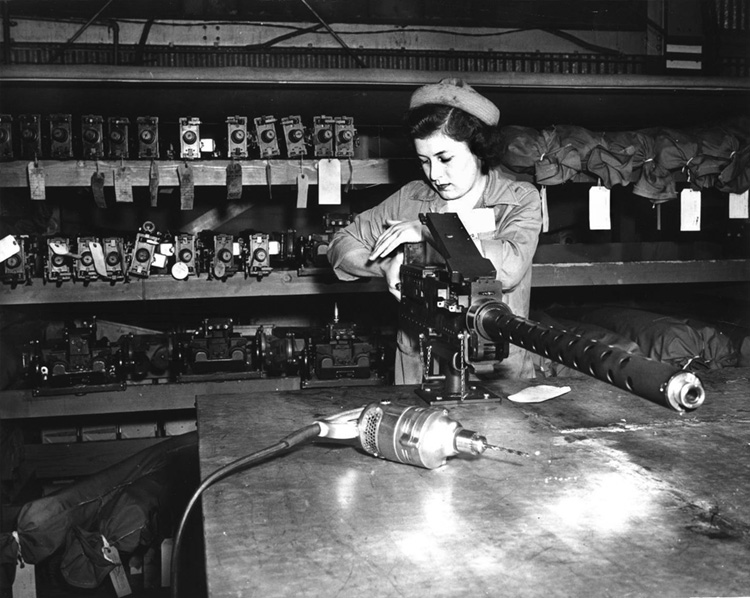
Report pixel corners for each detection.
[0,159,405,188]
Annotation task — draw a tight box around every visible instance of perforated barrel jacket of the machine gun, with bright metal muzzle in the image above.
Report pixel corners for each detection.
[467,300,706,412]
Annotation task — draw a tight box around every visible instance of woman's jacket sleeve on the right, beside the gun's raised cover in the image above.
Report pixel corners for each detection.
[482,183,542,291]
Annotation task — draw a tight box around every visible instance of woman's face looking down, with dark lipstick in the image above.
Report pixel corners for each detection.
[414,131,482,201]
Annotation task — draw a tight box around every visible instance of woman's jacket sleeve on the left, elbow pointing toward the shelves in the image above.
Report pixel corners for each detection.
[327,185,420,280]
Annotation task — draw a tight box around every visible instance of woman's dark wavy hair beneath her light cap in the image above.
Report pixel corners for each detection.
[405,104,502,174]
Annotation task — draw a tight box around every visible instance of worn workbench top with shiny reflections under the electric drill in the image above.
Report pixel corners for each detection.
[198,369,750,598]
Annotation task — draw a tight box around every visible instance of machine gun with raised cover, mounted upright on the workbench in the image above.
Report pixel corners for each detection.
[399,214,705,412]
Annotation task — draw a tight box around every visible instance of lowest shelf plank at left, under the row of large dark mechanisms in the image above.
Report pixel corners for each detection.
[0,376,302,420]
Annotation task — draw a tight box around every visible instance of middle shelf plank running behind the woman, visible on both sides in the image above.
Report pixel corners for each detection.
[0,259,750,306]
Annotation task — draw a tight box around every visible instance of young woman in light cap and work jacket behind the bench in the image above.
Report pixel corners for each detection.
[328,79,542,384]
